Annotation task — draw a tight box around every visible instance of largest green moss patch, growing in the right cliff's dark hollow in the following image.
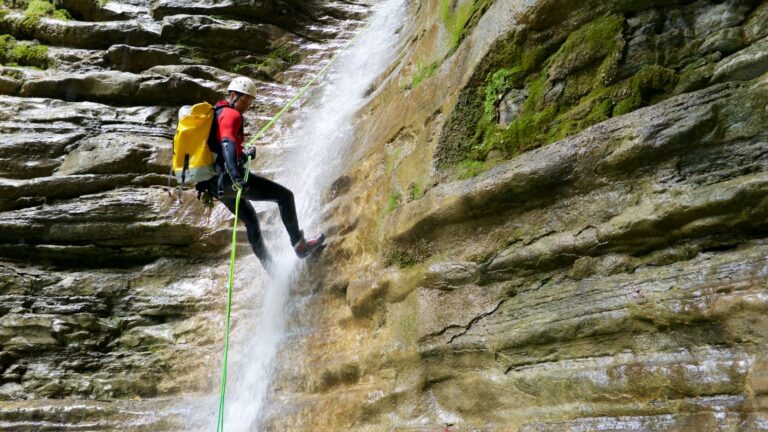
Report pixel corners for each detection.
[436,14,678,177]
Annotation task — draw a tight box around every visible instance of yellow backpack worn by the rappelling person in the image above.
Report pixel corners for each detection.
[169,102,216,199]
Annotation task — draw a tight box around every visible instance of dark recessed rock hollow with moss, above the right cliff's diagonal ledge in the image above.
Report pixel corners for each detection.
[436,0,760,176]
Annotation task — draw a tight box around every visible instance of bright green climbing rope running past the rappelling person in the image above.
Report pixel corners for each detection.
[216,17,370,432]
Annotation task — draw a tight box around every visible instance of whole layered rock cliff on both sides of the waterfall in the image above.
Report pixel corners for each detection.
[0,0,768,431]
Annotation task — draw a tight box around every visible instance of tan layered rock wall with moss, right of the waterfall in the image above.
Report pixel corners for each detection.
[264,0,768,431]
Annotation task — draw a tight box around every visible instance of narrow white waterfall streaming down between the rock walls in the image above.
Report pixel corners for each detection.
[184,0,405,432]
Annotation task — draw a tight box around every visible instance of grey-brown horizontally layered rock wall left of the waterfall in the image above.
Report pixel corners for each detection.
[0,0,366,431]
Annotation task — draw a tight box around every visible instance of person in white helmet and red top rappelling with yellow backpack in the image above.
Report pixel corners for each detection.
[173,77,325,272]
